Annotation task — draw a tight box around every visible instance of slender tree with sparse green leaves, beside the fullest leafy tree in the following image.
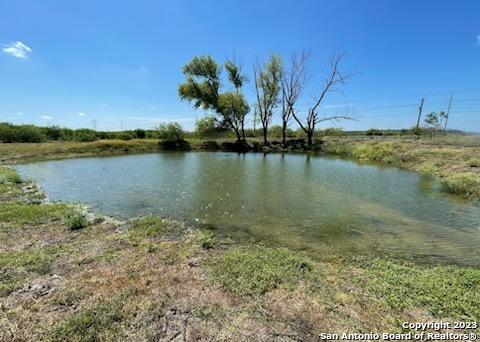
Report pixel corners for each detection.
[253,55,283,145]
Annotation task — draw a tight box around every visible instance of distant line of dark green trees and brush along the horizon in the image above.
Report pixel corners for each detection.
[0,121,462,143]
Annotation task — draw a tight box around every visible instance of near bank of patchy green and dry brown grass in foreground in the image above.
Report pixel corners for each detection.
[0,167,480,341]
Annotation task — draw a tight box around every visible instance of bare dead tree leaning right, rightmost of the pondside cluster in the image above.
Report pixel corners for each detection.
[292,54,354,148]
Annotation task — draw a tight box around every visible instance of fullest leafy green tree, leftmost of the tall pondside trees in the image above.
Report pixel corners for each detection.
[178,56,250,141]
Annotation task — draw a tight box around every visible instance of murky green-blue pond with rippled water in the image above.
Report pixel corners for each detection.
[15,152,480,265]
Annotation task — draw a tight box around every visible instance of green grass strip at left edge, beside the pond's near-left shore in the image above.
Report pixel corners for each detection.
[0,202,72,225]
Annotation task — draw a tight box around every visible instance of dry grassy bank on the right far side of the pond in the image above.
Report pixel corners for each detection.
[324,137,480,198]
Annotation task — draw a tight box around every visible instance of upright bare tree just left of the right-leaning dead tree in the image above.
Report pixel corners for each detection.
[282,51,309,147]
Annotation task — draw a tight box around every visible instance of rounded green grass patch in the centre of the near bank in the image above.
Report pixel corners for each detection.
[212,246,312,295]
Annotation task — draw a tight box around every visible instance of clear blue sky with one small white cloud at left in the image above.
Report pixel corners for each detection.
[0,0,480,131]
